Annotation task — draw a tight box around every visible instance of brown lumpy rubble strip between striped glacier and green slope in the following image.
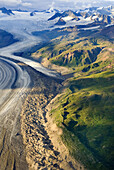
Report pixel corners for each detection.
[21,67,84,170]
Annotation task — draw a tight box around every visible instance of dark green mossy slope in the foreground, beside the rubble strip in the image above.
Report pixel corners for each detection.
[51,71,114,170]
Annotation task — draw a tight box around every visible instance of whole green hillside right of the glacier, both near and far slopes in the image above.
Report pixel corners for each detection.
[33,25,114,170]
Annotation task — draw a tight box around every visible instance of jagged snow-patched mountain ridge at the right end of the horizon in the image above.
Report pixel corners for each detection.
[48,7,114,25]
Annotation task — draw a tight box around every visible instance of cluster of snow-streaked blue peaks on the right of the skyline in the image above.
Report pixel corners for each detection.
[48,6,114,25]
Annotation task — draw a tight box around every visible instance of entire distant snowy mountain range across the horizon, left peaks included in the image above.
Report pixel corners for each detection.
[0,6,114,28]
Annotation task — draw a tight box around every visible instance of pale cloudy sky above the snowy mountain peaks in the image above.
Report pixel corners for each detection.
[0,0,114,10]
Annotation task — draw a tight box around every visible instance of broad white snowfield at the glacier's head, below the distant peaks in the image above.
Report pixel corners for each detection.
[0,11,93,39]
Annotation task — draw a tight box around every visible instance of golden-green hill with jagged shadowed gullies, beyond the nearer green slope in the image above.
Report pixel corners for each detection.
[34,30,114,71]
